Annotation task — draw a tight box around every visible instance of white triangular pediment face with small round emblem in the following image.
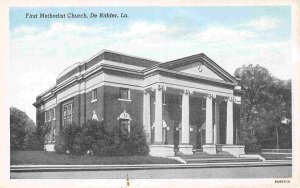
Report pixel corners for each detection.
[172,62,224,80]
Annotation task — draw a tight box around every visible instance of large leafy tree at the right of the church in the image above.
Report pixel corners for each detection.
[234,64,291,151]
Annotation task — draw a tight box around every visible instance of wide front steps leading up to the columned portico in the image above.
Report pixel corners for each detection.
[177,150,261,164]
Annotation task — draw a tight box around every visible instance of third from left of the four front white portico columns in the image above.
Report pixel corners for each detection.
[205,95,213,144]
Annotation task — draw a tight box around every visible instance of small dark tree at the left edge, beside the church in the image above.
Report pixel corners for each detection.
[10,107,36,150]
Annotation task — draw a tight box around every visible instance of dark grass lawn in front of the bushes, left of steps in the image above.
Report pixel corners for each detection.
[10,151,180,165]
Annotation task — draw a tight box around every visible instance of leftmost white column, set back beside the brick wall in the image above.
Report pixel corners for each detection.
[143,91,151,143]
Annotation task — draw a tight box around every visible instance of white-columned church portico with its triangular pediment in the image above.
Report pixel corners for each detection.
[143,52,244,157]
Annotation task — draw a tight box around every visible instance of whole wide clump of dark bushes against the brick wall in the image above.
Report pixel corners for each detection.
[55,120,149,156]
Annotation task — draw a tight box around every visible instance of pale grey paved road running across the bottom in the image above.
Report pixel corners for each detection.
[10,166,292,179]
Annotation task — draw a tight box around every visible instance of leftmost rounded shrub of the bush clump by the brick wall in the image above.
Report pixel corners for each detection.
[55,123,81,153]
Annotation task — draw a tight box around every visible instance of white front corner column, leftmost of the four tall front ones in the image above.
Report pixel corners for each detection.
[154,85,163,144]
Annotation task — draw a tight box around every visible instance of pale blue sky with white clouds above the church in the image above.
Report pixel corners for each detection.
[9,6,293,121]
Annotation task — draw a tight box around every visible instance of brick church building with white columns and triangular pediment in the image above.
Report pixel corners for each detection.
[33,50,244,157]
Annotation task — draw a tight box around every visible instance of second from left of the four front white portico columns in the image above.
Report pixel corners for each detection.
[181,90,190,144]
